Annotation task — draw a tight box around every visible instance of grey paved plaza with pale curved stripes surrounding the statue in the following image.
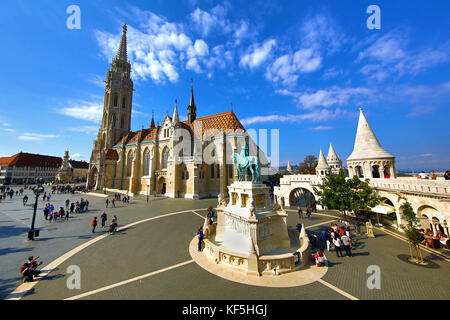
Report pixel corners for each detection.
[0,191,450,300]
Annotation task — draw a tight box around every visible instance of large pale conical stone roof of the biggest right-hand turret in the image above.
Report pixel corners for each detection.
[347,108,394,161]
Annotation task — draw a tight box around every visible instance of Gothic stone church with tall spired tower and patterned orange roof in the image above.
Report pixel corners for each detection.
[87,25,267,199]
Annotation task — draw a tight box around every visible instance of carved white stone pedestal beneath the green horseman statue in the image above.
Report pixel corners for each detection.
[200,182,309,276]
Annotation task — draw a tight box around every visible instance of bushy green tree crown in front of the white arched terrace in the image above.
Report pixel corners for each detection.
[313,169,380,219]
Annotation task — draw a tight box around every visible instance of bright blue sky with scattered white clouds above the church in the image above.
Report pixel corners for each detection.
[0,0,450,169]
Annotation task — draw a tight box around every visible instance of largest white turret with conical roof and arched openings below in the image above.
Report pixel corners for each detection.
[347,108,397,178]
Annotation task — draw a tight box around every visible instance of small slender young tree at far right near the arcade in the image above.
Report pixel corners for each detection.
[400,201,423,263]
